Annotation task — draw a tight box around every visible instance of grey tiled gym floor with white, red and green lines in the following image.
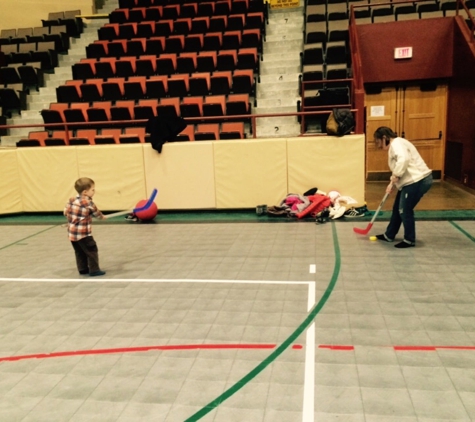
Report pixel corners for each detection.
[0,183,475,422]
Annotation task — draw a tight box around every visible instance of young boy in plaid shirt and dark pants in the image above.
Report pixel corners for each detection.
[63,177,106,277]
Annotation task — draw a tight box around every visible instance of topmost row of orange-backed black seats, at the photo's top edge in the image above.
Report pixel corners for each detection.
[109,0,265,23]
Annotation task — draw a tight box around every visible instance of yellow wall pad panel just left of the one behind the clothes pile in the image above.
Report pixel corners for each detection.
[214,139,287,208]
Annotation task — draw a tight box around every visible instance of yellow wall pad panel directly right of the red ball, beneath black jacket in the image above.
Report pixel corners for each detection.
[143,142,216,209]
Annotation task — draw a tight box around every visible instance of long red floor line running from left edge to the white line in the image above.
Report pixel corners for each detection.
[0,343,302,362]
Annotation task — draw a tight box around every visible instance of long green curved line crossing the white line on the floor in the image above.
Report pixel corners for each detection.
[185,222,341,422]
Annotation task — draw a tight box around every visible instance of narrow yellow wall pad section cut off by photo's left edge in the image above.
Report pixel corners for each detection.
[0,150,23,214]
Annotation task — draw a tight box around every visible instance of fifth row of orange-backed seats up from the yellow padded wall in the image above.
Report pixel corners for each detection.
[86,29,262,59]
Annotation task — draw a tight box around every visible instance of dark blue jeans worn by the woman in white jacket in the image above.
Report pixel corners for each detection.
[385,174,432,245]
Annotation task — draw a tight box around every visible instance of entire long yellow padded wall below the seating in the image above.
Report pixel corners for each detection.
[0,135,365,214]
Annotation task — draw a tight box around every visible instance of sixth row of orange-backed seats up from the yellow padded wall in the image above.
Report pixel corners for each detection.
[97,13,265,40]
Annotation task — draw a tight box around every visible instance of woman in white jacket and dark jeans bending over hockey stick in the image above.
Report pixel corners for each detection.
[374,126,432,248]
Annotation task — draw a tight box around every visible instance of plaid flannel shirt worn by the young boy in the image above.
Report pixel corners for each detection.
[63,195,103,242]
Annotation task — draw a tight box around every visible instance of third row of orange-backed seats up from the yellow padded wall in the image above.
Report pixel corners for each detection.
[56,70,255,103]
